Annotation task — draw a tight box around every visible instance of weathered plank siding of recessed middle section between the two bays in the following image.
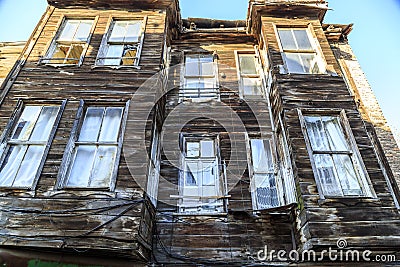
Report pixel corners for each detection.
[153,29,294,266]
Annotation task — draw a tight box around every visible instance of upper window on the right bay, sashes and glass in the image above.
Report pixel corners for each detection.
[278,28,325,74]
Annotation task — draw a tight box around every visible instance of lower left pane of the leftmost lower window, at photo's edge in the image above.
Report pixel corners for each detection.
[0,146,28,186]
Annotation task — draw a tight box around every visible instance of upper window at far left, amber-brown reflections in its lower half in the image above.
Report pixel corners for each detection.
[42,19,93,65]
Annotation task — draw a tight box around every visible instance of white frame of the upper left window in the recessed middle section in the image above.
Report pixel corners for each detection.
[179,53,220,102]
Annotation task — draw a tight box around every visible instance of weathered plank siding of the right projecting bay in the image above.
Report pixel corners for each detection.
[260,7,400,260]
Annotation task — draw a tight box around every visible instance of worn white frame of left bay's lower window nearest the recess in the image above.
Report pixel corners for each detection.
[57,100,129,191]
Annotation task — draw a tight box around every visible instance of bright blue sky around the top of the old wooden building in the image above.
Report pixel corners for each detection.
[0,0,400,134]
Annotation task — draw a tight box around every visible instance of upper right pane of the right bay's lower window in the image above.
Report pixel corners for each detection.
[321,117,350,151]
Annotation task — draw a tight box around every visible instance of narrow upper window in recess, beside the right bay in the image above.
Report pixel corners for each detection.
[237,52,264,97]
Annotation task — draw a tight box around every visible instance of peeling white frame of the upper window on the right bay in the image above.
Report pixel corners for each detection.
[275,25,326,74]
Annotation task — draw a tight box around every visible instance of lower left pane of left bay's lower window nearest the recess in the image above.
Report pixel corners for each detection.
[66,145,96,187]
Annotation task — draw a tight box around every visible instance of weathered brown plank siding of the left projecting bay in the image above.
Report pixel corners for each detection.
[0,4,166,262]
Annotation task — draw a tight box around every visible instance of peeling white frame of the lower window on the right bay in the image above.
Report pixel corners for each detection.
[298,110,376,199]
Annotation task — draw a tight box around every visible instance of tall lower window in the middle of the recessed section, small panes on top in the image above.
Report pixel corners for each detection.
[179,138,224,213]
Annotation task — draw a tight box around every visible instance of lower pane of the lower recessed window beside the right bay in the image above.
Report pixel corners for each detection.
[253,174,279,209]
